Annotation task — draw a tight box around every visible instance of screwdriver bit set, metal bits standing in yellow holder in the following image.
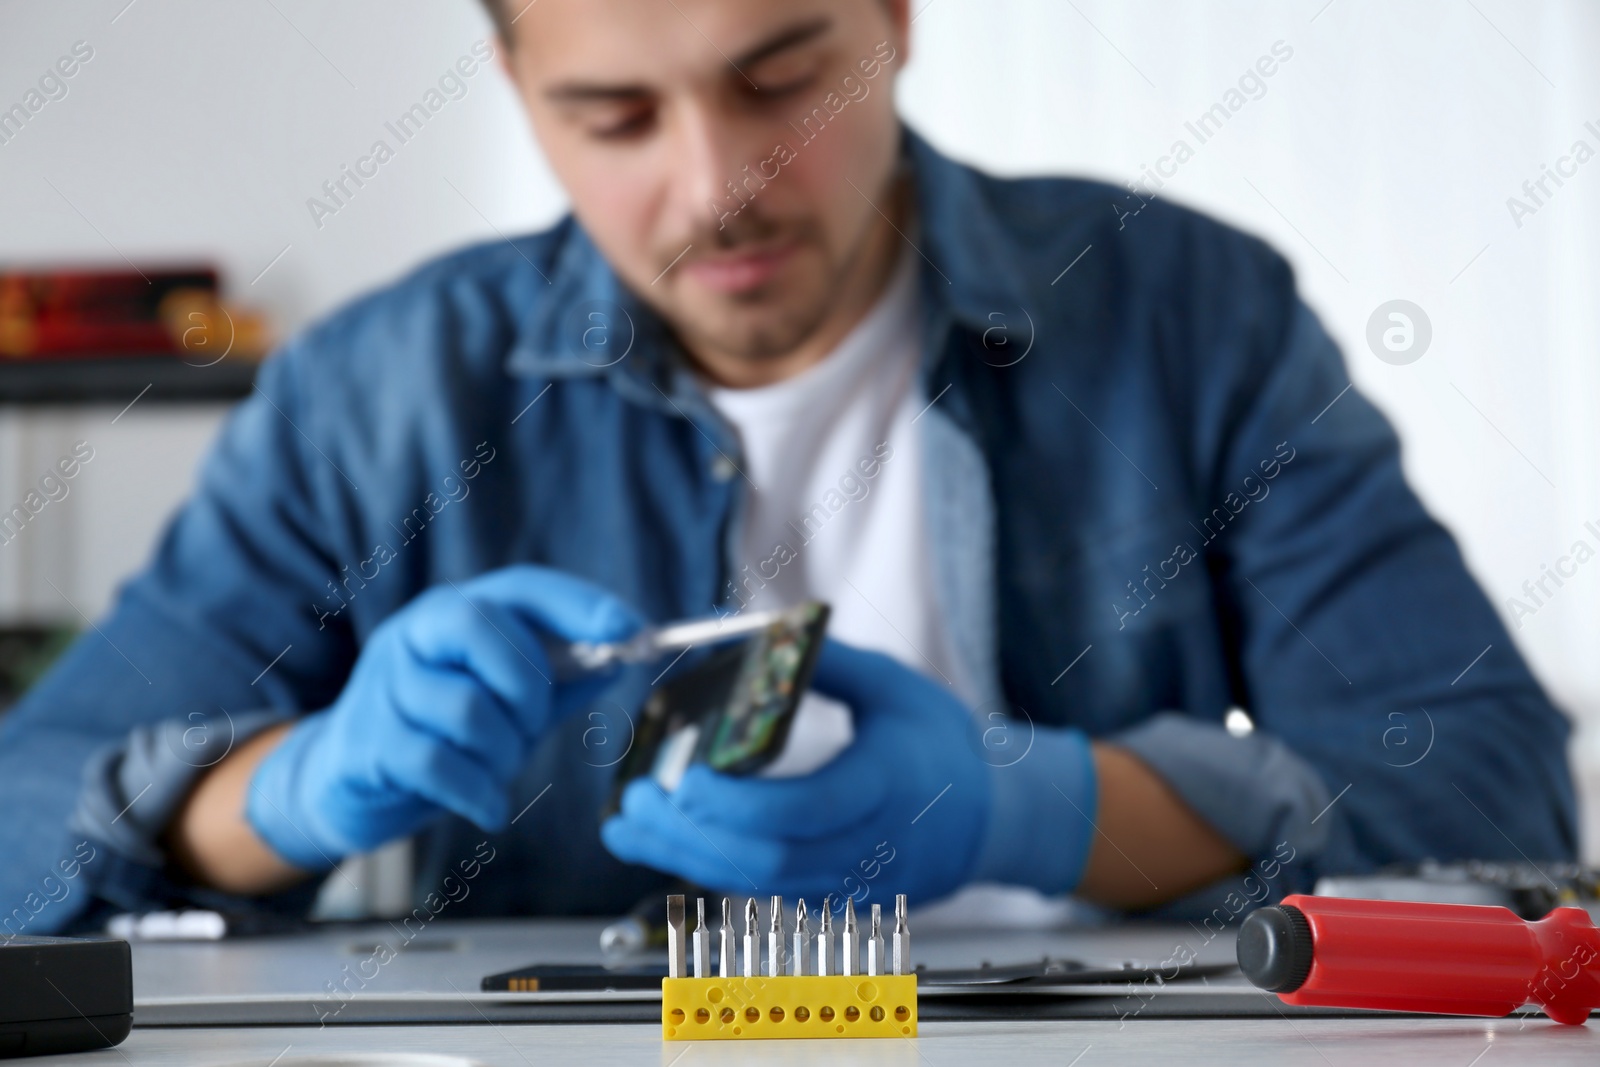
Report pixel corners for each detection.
[661,894,917,1041]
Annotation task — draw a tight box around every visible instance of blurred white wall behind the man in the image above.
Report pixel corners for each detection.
[0,0,1600,854]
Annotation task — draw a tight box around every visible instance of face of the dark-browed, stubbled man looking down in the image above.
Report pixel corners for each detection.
[509,0,906,367]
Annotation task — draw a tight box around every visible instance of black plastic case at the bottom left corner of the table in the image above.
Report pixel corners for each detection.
[0,937,133,1059]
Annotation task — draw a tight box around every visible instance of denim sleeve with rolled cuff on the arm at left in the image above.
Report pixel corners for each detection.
[0,352,355,936]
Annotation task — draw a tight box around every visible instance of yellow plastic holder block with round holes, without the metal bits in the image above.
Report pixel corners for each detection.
[661,974,917,1041]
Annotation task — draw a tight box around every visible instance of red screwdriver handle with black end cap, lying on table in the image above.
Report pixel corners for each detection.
[1238,894,1600,1025]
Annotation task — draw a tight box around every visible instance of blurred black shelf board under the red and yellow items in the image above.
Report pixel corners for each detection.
[0,355,261,405]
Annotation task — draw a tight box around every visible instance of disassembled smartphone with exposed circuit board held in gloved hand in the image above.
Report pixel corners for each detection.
[611,600,829,809]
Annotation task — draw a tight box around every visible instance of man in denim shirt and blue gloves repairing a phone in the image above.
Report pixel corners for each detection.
[0,0,1574,933]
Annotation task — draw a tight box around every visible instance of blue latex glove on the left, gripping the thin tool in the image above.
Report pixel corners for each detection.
[245,566,642,870]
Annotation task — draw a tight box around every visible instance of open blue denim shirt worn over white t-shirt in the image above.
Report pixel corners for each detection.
[0,131,1574,933]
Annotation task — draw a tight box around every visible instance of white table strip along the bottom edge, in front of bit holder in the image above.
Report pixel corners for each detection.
[40,1017,1600,1067]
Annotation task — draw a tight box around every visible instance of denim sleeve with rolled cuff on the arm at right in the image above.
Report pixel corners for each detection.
[1177,286,1576,891]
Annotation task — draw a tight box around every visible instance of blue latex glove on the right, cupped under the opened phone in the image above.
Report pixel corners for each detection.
[600,640,1096,902]
